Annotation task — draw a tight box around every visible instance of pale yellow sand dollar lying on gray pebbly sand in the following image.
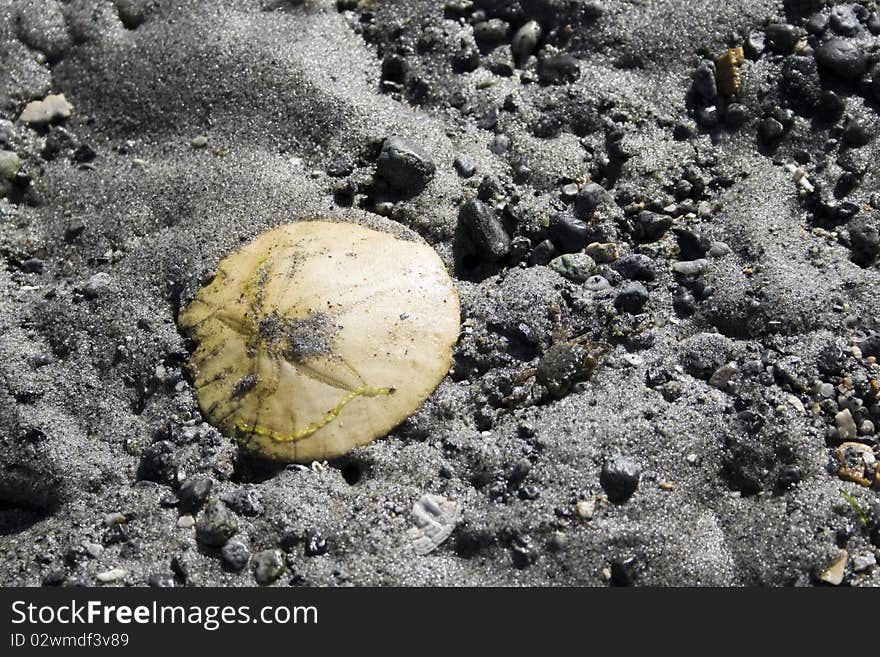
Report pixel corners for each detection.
[179,219,459,462]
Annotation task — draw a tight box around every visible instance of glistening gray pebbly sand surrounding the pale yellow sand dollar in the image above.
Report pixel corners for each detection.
[0,0,880,586]
